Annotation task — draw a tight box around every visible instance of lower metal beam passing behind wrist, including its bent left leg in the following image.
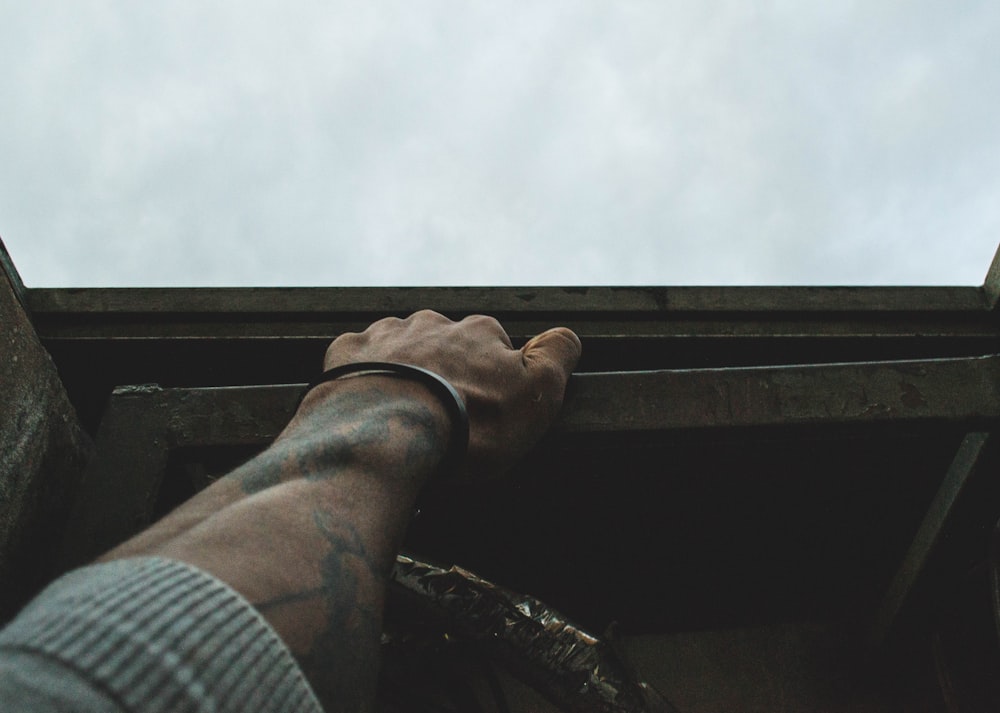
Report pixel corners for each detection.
[58,356,1000,564]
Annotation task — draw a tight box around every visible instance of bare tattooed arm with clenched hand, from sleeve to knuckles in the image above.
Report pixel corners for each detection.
[97,312,580,711]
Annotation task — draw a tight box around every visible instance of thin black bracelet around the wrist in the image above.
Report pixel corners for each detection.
[299,361,469,477]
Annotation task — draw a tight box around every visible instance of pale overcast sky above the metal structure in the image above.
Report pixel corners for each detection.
[0,0,1000,286]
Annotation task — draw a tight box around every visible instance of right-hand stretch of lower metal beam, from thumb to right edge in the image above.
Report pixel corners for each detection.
[556,356,1000,433]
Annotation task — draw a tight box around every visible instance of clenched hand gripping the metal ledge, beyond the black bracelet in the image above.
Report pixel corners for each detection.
[324,310,580,476]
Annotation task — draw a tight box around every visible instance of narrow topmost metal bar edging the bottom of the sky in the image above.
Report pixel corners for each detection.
[28,287,987,318]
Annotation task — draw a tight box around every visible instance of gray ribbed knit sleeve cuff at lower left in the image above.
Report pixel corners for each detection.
[0,558,322,713]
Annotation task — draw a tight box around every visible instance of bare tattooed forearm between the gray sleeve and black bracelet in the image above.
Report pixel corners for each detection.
[104,376,449,710]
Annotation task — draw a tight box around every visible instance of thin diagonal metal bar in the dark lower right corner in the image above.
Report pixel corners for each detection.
[868,432,989,648]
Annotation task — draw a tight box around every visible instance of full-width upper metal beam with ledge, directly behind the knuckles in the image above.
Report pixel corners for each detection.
[28,287,1000,340]
